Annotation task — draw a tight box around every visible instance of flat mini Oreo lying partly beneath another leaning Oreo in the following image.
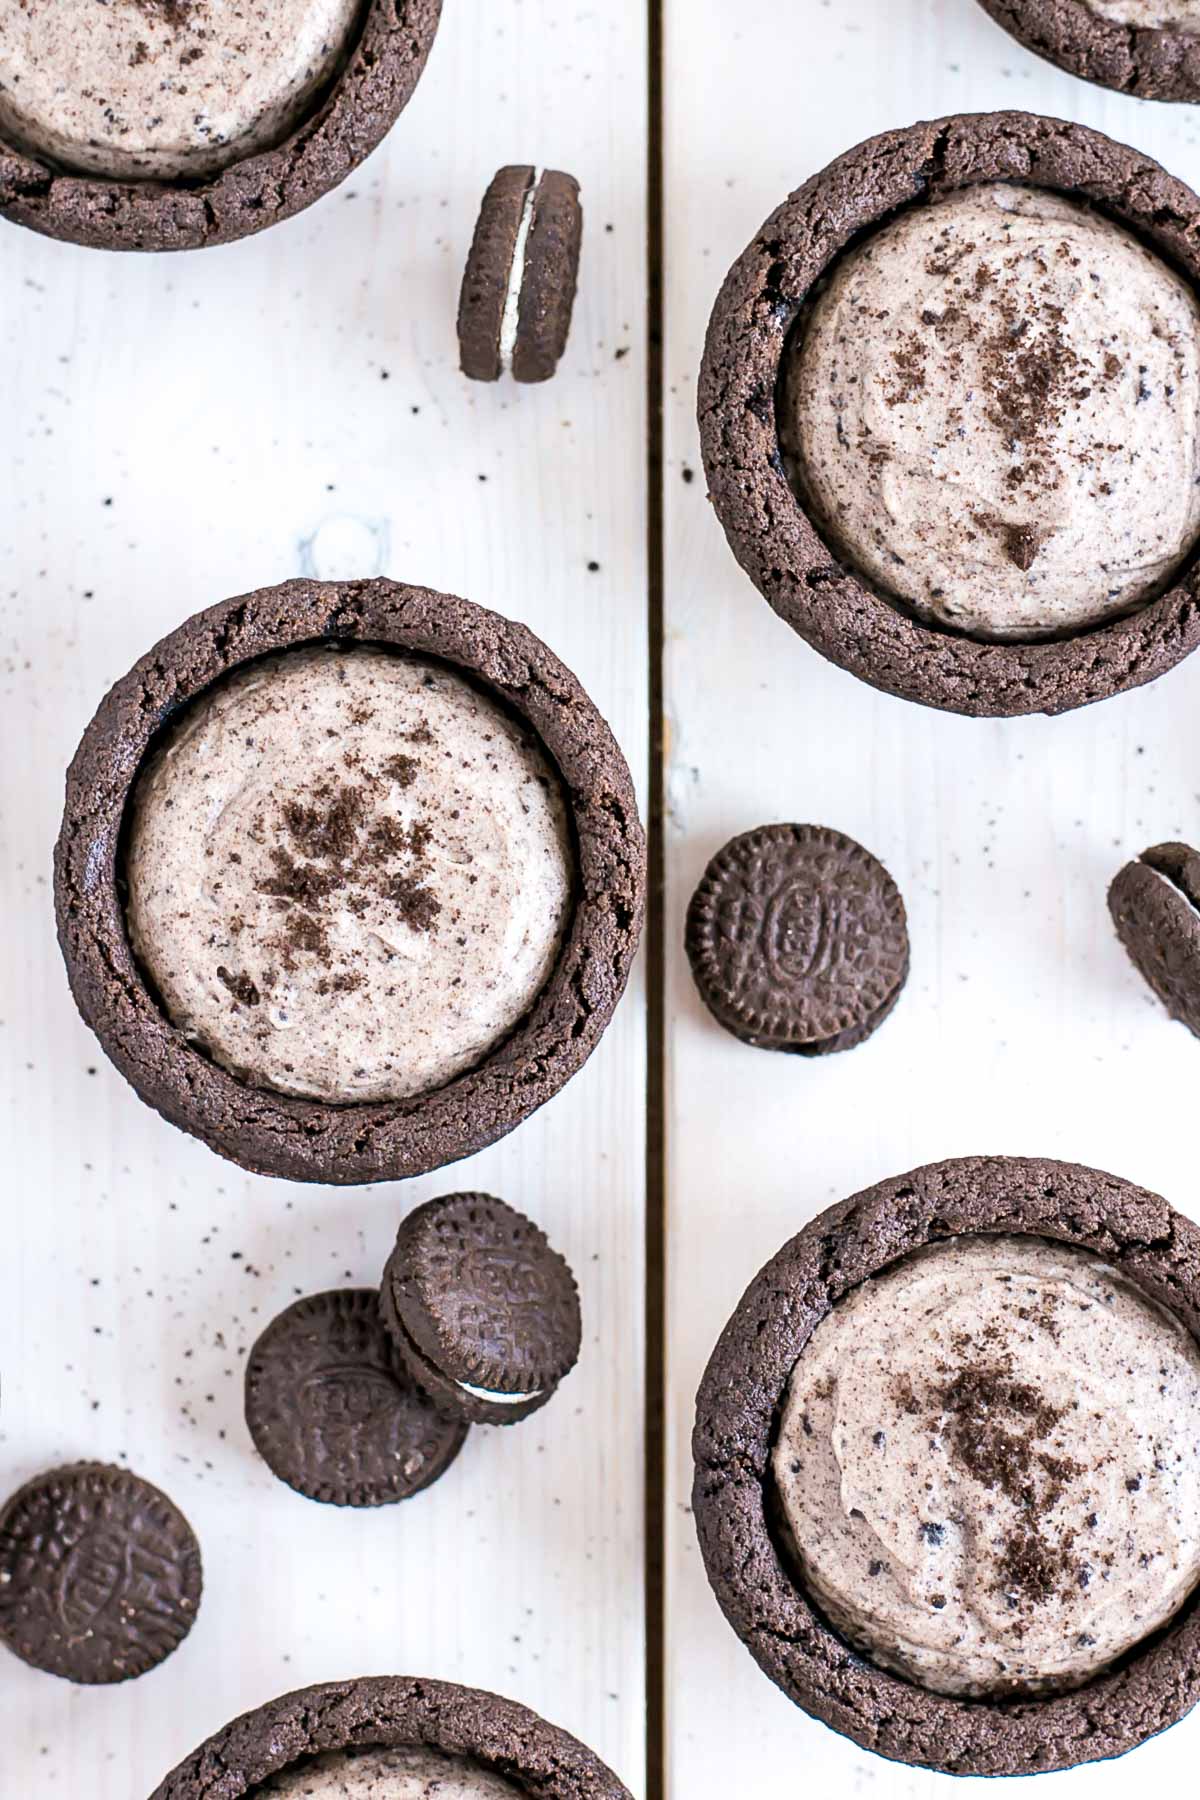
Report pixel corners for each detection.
[246,1287,466,1507]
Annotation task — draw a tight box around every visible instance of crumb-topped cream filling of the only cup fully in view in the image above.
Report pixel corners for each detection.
[126,648,574,1102]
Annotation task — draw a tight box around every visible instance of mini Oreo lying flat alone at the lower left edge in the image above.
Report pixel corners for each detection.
[0,1463,203,1687]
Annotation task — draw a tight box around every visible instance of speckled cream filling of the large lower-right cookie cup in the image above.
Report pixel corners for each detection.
[774,1237,1200,1696]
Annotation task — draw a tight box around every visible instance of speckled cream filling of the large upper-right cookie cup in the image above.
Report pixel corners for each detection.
[779,185,1200,639]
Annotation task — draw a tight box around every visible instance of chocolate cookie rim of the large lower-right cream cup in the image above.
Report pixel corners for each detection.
[693,1156,1200,1775]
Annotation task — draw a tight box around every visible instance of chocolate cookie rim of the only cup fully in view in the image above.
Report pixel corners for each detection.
[54,580,646,1184]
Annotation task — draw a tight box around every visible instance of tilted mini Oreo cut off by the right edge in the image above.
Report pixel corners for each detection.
[1108,844,1200,1037]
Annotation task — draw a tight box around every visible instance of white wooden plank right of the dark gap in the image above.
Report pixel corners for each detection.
[666,0,1200,1800]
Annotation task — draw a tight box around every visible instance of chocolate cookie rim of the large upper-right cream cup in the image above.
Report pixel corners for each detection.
[698,112,1200,716]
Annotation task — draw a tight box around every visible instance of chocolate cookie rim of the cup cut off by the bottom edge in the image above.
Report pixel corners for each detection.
[151,1676,630,1800]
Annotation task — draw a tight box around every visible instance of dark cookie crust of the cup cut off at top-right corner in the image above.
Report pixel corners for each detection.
[981,0,1200,101]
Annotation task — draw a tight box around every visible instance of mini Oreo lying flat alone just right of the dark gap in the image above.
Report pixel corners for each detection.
[685,824,909,1057]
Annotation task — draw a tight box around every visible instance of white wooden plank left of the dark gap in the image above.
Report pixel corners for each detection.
[0,0,646,1800]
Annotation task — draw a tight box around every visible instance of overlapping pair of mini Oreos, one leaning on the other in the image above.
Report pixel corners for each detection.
[246,1193,581,1507]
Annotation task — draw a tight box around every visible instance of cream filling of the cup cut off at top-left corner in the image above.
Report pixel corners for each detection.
[0,0,362,180]
